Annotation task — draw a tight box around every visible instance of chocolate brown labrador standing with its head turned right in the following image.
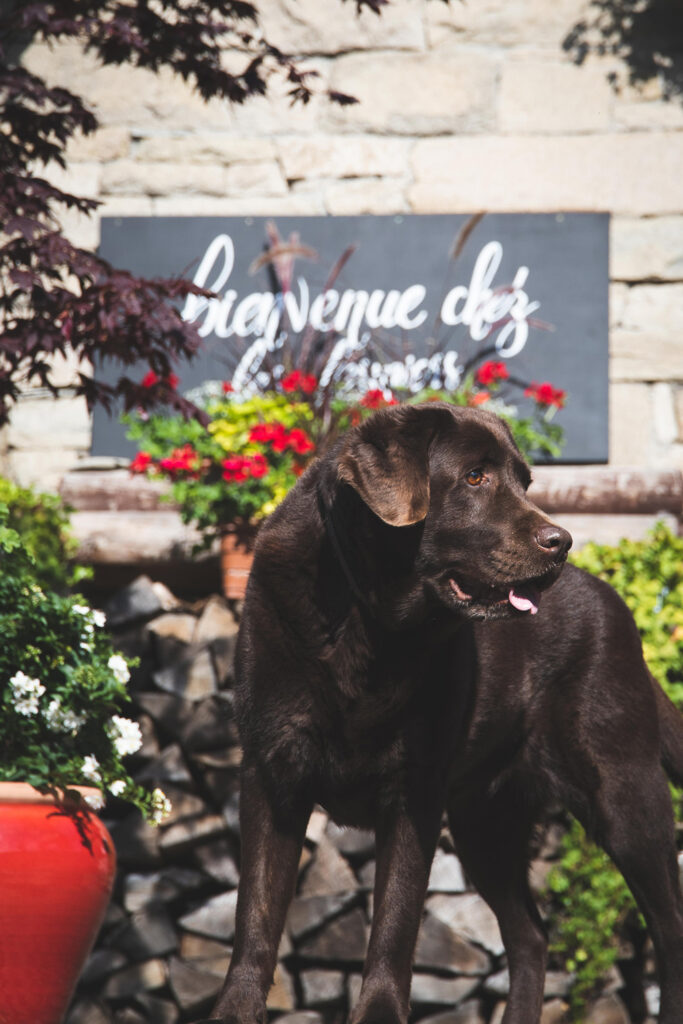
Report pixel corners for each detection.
[200,403,683,1024]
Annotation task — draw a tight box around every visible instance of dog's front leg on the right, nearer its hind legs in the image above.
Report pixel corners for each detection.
[351,787,442,1024]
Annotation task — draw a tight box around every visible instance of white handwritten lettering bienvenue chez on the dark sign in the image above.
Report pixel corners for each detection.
[182,234,540,386]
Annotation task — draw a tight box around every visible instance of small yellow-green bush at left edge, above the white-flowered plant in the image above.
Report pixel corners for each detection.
[0,477,85,591]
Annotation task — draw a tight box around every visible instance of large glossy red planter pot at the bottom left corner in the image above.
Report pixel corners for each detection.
[0,782,116,1024]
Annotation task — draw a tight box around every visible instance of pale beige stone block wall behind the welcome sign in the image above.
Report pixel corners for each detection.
[4,0,683,486]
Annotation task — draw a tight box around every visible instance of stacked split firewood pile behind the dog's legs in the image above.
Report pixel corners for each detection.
[68,577,656,1024]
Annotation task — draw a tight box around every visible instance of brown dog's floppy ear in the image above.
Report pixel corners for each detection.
[338,406,451,526]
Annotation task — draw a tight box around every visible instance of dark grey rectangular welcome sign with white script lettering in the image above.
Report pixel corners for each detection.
[93,213,609,462]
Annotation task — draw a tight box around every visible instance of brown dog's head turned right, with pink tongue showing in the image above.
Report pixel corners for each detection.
[337,402,571,618]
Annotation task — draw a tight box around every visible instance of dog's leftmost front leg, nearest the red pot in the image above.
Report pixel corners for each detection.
[200,766,310,1024]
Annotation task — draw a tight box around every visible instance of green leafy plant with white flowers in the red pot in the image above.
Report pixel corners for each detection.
[0,504,169,820]
